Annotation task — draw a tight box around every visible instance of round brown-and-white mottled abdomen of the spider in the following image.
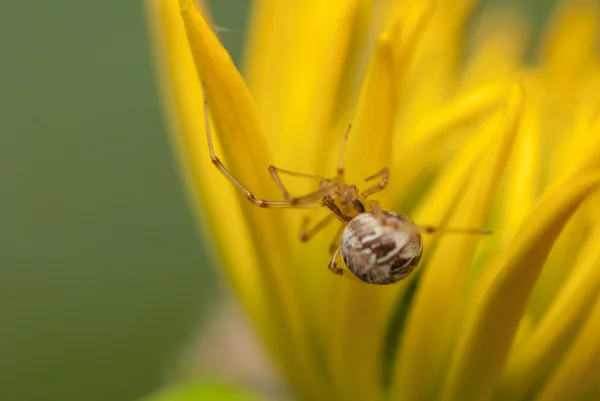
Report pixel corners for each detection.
[341,211,423,284]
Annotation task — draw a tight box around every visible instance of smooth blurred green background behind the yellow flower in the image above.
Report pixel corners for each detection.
[0,0,550,401]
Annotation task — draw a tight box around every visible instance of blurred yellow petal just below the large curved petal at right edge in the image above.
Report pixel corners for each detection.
[501,220,600,400]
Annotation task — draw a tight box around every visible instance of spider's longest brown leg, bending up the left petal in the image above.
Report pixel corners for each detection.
[202,84,335,209]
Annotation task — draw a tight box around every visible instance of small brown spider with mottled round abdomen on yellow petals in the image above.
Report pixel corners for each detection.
[203,87,491,285]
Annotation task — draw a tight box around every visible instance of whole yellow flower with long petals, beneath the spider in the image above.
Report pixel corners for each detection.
[149,0,600,401]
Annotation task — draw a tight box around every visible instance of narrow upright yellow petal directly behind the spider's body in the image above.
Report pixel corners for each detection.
[324,34,396,400]
